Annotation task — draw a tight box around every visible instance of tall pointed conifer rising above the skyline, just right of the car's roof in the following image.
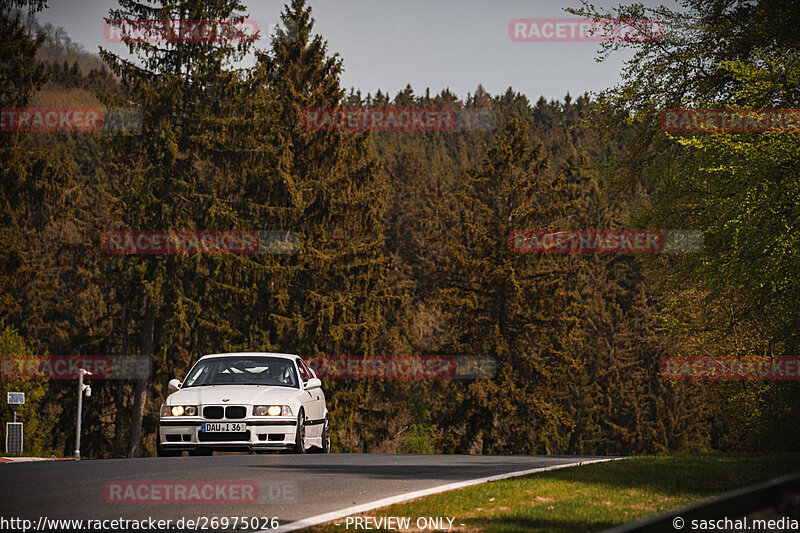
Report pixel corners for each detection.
[247,0,399,449]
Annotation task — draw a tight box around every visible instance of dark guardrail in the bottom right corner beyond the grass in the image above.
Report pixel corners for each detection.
[603,474,800,533]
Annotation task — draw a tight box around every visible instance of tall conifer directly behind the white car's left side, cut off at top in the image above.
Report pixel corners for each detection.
[101,0,258,456]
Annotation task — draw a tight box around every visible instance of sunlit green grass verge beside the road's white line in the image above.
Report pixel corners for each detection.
[306,453,800,533]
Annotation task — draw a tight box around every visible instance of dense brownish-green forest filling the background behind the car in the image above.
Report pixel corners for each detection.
[0,0,800,457]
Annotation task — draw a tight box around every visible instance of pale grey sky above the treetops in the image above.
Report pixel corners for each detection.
[38,0,679,101]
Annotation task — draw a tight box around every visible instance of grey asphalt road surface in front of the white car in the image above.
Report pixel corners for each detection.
[0,454,616,531]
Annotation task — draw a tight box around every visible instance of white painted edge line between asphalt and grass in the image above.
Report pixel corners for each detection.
[268,457,627,533]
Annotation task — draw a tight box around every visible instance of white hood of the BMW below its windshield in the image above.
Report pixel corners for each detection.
[167,385,300,405]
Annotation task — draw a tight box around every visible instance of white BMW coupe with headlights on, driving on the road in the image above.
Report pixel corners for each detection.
[157,353,331,457]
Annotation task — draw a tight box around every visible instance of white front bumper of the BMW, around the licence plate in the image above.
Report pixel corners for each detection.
[158,417,297,451]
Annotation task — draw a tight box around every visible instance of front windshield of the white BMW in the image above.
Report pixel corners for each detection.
[181,357,298,389]
